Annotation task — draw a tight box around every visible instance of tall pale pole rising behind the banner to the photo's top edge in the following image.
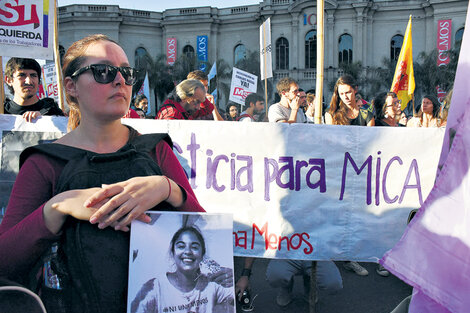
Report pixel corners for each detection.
[315,0,325,124]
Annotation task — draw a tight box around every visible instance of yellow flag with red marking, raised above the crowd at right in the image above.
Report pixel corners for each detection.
[390,15,415,110]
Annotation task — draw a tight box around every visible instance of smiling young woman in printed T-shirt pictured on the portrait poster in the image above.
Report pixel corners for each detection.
[131,226,234,313]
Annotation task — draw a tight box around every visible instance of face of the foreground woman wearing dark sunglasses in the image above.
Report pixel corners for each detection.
[66,41,132,121]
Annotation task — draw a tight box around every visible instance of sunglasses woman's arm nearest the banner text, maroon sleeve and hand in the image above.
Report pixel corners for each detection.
[85,141,204,231]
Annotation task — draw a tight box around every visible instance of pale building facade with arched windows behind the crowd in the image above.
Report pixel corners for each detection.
[58,0,468,107]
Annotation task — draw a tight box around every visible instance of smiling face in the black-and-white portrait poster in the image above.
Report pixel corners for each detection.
[173,231,203,271]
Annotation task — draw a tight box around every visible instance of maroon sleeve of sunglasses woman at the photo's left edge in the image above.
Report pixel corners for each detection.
[0,154,58,282]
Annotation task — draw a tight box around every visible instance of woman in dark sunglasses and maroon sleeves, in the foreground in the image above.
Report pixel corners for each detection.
[0,35,204,312]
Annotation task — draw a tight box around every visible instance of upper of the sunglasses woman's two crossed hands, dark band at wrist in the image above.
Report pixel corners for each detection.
[85,175,183,231]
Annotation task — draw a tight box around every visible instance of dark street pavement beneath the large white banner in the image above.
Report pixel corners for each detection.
[237,259,412,313]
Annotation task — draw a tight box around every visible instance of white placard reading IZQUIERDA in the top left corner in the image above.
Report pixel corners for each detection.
[0,0,55,60]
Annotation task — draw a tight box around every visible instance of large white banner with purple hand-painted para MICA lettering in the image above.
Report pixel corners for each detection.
[0,115,444,261]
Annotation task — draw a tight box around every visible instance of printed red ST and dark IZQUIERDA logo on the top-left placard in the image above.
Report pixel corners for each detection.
[0,0,49,47]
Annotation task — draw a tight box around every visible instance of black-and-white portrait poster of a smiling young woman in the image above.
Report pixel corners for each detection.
[127,212,235,313]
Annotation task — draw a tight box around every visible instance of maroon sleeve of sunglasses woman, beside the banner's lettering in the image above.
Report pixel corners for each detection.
[155,140,205,212]
